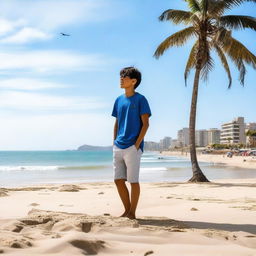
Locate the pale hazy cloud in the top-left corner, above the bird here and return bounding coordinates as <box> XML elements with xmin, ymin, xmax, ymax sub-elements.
<box><xmin>0</xmin><ymin>0</ymin><xmax>113</xmax><ymax>29</ymax></box>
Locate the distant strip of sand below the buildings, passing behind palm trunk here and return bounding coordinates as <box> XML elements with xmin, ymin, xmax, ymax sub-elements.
<box><xmin>161</xmin><ymin>151</ymin><xmax>256</xmax><ymax>170</ymax></box>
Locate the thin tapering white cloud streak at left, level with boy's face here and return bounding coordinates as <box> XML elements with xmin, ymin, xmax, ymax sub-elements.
<box><xmin>0</xmin><ymin>78</ymin><xmax>68</xmax><ymax>90</ymax></box>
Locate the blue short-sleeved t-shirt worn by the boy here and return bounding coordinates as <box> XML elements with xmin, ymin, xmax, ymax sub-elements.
<box><xmin>112</xmin><ymin>92</ymin><xmax>151</xmax><ymax>151</ymax></box>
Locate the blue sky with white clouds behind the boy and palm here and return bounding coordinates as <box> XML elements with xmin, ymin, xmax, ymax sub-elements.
<box><xmin>0</xmin><ymin>0</ymin><xmax>256</xmax><ymax>150</ymax></box>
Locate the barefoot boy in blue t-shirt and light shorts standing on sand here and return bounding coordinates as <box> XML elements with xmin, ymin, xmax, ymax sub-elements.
<box><xmin>112</xmin><ymin>67</ymin><xmax>151</xmax><ymax>219</ymax></box>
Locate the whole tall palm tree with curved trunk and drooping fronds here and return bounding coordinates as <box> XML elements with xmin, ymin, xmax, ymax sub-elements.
<box><xmin>154</xmin><ymin>0</ymin><xmax>256</xmax><ymax>182</ymax></box>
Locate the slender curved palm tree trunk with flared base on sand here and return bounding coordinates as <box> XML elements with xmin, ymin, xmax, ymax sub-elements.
<box><xmin>189</xmin><ymin>68</ymin><xmax>209</xmax><ymax>182</ymax></box>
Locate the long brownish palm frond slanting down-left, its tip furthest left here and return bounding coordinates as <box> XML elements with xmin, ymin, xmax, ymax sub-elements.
<box><xmin>154</xmin><ymin>27</ymin><xmax>196</xmax><ymax>58</ymax></box>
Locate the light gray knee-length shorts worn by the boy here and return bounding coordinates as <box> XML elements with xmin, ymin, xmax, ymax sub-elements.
<box><xmin>113</xmin><ymin>145</ymin><xmax>142</xmax><ymax>183</ymax></box>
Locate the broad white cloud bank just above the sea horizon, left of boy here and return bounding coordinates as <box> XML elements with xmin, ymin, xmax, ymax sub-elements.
<box><xmin>0</xmin><ymin>113</ymin><xmax>113</xmax><ymax>150</ymax></box>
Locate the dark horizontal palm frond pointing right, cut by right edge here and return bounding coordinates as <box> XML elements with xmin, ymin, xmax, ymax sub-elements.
<box><xmin>219</xmin><ymin>15</ymin><xmax>256</xmax><ymax>30</ymax></box>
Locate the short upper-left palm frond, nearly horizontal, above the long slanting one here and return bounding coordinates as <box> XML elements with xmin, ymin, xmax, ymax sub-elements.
<box><xmin>159</xmin><ymin>9</ymin><xmax>197</xmax><ymax>24</ymax></box>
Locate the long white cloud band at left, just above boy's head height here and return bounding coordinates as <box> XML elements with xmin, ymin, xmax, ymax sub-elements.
<box><xmin>0</xmin><ymin>50</ymin><xmax>106</xmax><ymax>74</ymax></box>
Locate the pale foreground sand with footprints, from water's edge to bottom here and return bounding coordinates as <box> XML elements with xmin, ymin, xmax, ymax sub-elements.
<box><xmin>0</xmin><ymin>179</ymin><xmax>256</xmax><ymax>256</ymax></box>
